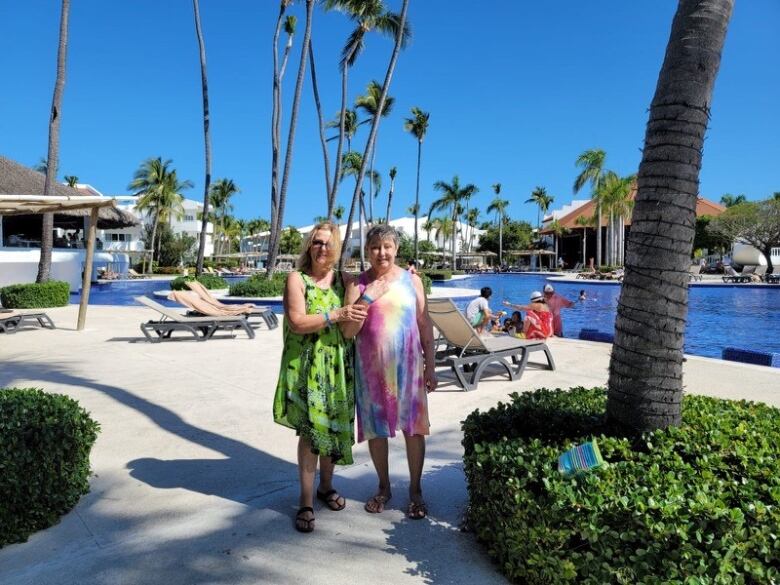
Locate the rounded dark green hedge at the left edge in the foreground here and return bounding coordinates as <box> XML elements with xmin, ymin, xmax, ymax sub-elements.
<box><xmin>0</xmin><ymin>388</ymin><xmax>100</xmax><ymax>547</ymax></box>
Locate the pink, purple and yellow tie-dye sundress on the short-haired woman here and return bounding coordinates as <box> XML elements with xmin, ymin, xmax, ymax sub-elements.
<box><xmin>355</xmin><ymin>270</ymin><xmax>430</xmax><ymax>441</ymax></box>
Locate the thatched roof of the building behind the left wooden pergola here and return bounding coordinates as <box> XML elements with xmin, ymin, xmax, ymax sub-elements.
<box><xmin>0</xmin><ymin>155</ymin><xmax>140</xmax><ymax>230</ymax></box>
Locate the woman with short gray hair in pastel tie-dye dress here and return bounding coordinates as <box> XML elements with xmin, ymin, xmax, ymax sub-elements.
<box><xmin>343</xmin><ymin>224</ymin><xmax>437</xmax><ymax>519</ymax></box>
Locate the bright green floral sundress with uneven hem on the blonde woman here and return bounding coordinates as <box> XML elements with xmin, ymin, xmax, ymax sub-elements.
<box><xmin>274</xmin><ymin>272</ymin><xmax>355</xmax><ymax>465</ymax></box>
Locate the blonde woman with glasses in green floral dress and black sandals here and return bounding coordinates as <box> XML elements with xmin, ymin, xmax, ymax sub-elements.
<box><xmin>274</xmin><ymin>222</ymin><xmax>367</xmax><ymax>532</ymax></box>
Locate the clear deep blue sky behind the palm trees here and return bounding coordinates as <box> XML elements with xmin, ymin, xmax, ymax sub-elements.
<box><xmin>0</xmin><ymin>0</ymin><xmax>780</xmax><ymax>225</ymax></box>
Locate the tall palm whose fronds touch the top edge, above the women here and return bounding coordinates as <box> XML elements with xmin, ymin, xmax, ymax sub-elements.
<box><xmin>323</xmin><ymin>0</ymin><xmax>411</xmax><ymax>210</ymax></box>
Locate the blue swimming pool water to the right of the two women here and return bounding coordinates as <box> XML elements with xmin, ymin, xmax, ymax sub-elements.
<box><xmin>436</xmin><ymin>274</ymin><xmax>780</xmax><ymax>358</ymax></box>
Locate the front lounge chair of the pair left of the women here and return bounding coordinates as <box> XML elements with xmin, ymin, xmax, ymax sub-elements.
<box><xmin>134</xmin><ymin>297</ymin><xmax>255</xmax><ymax>343</ymax></box>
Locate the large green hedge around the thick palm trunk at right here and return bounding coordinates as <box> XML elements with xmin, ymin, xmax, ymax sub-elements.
<box><xmin>463</xmin><ymin>388</ymin><xmax>780</xmax><ymax>585</ymax></box>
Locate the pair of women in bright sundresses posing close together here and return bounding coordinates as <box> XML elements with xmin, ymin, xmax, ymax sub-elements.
<box><xmin>274</xmin><ymin>222</ymin><xmax>436</xmax><ymax>532</ymax></box>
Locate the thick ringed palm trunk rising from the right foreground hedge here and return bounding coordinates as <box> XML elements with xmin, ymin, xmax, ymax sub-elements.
<box><xmin>607</xmin><ymin>0</ymin><xmax>734</xmax><ymax>431</ymax></box>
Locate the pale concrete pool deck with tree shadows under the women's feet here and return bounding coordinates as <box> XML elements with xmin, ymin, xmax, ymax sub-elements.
<box><xmin>0</xmin><ymin>305</ymin><xmax>780</xmax><ymax>585</ymax></box>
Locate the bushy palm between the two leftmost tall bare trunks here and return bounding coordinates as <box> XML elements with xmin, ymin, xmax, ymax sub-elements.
<box><xmin>128</xmin><ymin>157</ymin><xmax>192</xmax><ymax>271</ymax></box>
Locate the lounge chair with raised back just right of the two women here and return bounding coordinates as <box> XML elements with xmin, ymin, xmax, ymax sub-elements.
<box><xmin>428</xmin><ymin>299</ymin><xmax>555</xmax><ymax>390</ymax></box>
